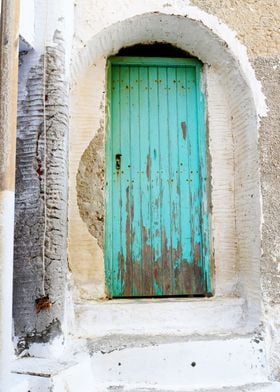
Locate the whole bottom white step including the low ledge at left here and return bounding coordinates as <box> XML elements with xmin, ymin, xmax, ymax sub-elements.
<box><xmin>8</xmin><ymin>335</ymin><xmax>274</xmax><ymax>392</ymax></box>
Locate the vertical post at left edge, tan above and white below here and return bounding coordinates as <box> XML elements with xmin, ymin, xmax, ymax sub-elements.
<box><xmin>0</xmin><ymin>0</ymin><xmax>19</xmax><ymax>391</ymax></box>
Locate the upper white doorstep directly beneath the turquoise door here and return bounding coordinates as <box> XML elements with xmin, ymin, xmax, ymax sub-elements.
<box><xmin>73</xmin><ymin>298</ymin><xmax>247</xmax><ymax>338</ymax></box>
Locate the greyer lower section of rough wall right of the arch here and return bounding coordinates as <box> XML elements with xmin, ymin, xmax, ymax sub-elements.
<box><xmin>253</xmin><ymin>56</ymin><xmax>280</xmax><ymax>380</ymax></box>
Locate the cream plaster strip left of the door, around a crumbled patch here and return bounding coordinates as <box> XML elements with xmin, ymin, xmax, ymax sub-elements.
<box><xmin>68</xmin><ymin>58</ymin><xmax>106</xmax><ymax>299</ymax></box>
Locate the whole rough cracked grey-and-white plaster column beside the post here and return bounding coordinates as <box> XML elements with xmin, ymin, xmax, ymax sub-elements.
<box><xmin>14</xmin><ymin>31</ymin><xmax>68</xmax><ymax>350</ymax></box>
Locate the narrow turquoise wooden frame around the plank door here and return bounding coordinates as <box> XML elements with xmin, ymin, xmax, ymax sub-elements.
<box><xmin>104</xmin><ymin>56</ymin><xmax>214</xmax><ymax>298</ymax></box>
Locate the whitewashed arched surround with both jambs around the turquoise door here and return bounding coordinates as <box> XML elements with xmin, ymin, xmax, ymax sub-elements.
<box><xmin>69</xmin><ymin>11</ymin><xmax>263</xmax><ymax>328</ymax></box>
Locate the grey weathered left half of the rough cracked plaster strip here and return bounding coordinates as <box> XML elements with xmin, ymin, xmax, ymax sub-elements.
<box><xmin>13</xmin><ymin>52</ymin><xmax>44</xmax><ymax>334</ymax></box>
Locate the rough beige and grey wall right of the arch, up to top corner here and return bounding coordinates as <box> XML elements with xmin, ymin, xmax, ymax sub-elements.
<box><xmin>192</xmin><ymin>0</ymin><xmax>280</xmax><ymax>379</ymax></box>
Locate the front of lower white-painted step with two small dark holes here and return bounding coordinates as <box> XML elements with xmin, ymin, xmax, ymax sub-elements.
<box><xmin>88</xmin><ymin>336</ymin><xmax>270</xmax><ymax>392</ymax></box>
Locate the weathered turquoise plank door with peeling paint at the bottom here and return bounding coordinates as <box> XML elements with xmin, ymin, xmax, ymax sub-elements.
<box><xmin>105</xmin><ymin>57</ymin><xmax>211</xmax><ymax>297</ymax></box>
